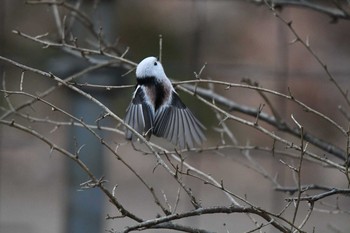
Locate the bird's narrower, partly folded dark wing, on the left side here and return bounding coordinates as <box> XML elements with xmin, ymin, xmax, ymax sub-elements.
<box><xmin>124</xmin><ymin>86</ymin><xmax>154</xmax><ymax>140</ymax></box>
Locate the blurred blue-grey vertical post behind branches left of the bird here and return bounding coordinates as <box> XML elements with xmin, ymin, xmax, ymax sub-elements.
<box><xmin>65</xmin><ymin>0</ymin><xmax>118</xmax><ymax>233</ymax></box>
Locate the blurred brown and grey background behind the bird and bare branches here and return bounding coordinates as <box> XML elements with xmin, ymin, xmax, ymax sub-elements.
<box><xmin>0</xmin><ymin>0</ymin><xmax>350</xmax><ymax>233</ymax></box>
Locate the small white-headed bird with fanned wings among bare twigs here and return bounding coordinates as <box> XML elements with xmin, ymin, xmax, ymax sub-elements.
<box><xmin>124</xmin><ymin>56</ymin><xmax>206</xmax><ymax>149</ymax></box>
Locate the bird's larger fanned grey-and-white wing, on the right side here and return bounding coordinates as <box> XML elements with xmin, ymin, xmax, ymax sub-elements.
<box><xmin>153</xmin><ymin>92</ymin><xmax>205</xmax><ymax>148</ymax></box>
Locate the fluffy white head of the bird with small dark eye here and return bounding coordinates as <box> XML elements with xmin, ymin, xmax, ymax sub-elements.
<box><xmin>136</xmin><ymin>57</ymin><xmax>166</xmax><ymax>80</ymax></box>
